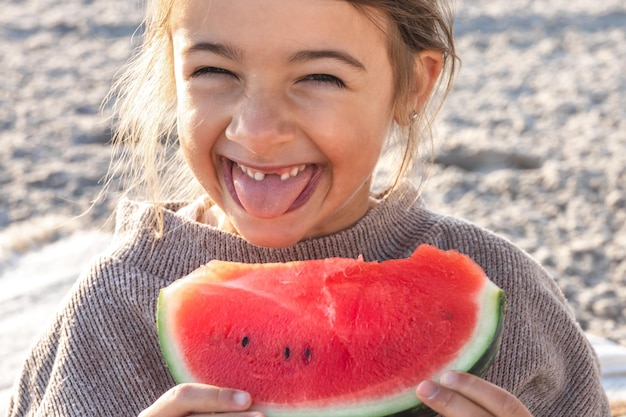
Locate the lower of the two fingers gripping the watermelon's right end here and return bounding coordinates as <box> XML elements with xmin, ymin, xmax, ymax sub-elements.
<box><xmin>417</xmin><ymin>381</ymin><xmax>495</xmax><ymax>417</ymax></box>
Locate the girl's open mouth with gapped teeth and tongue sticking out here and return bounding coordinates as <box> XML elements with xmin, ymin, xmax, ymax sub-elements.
<box><xmin>221</xmin><ymin>157</ymin><xmax>322</xmax><ymax>219</ymax></box>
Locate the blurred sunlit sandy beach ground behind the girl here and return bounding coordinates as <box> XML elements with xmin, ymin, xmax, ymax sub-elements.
<box><xmin>0</xmin><ymin>0</ymin><xmax>626</xmax><ymax>415</ymax></box>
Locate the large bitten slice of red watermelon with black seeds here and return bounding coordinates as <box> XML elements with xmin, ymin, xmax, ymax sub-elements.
<box><xmin>157</xmin><ymin>245</ymin><xmax>505</xmax><ymax>417</ymax></box>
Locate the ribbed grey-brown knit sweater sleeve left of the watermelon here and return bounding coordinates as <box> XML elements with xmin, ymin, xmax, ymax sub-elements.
<box><xmin>8</xmin><ymin>256</ymin><xmax>174</xmax><ymax>417</ymax></box>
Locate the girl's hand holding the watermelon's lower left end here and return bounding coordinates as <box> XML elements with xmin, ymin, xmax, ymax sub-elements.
<box><xmin>139</xmin><ymin>384</ymin><xmax>263</xmax><ymax>417</ymax></box>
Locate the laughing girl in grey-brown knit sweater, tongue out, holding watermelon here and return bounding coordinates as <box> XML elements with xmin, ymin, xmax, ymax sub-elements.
<box><xmin>10</xmin><ymin>0</ymin><xmax>609</xmax><ymax>417</ymax></box>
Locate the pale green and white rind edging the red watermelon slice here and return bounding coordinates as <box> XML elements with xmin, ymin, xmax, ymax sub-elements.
<box><xmin>157</xmin><ymin>281</ymin><xmax>506</xmax><ymax>417</ymax></box>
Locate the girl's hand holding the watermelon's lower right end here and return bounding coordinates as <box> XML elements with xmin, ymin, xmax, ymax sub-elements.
<box><xmin>417</xmin><ymin>372</ymin><xmax>532</xmax><ymax>417</ymax></box>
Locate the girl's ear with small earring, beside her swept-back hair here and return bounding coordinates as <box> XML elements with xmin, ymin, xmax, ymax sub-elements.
<box><xmin>396</xmin><ymin>50</ymin><xmax>443</xmax><ymax>125</ymax></box>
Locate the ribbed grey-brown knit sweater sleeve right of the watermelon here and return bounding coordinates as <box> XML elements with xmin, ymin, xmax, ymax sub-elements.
<box><xmin>424</xmin><ymin>218</ymin><xmax>610</xmax><ymax>417</ymax></box>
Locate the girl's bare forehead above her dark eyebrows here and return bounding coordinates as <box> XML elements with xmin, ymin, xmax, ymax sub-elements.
<box><xmin>170</xmin><ymin>0</ymin><xmax>387</xmax><ymax>57</ymax></box>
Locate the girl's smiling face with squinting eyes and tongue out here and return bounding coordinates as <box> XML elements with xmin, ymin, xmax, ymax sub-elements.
<box><xmin>172</xmin><ymin>0</ymin><xmax>394</xmax><ymax>247</ymax></box>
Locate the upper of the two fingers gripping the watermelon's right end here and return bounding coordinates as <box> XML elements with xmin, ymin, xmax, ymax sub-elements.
<box><xmin>440</xmin><ymin>372</ymin><xmax>532</xmax><ymax>417</ymax></box>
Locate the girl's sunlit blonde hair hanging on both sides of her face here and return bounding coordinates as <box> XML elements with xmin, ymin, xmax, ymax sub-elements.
<box><xmin>108</xmin><ymin>0</ymin><xmax>458</xmax><ymax>231</ymax></box>
